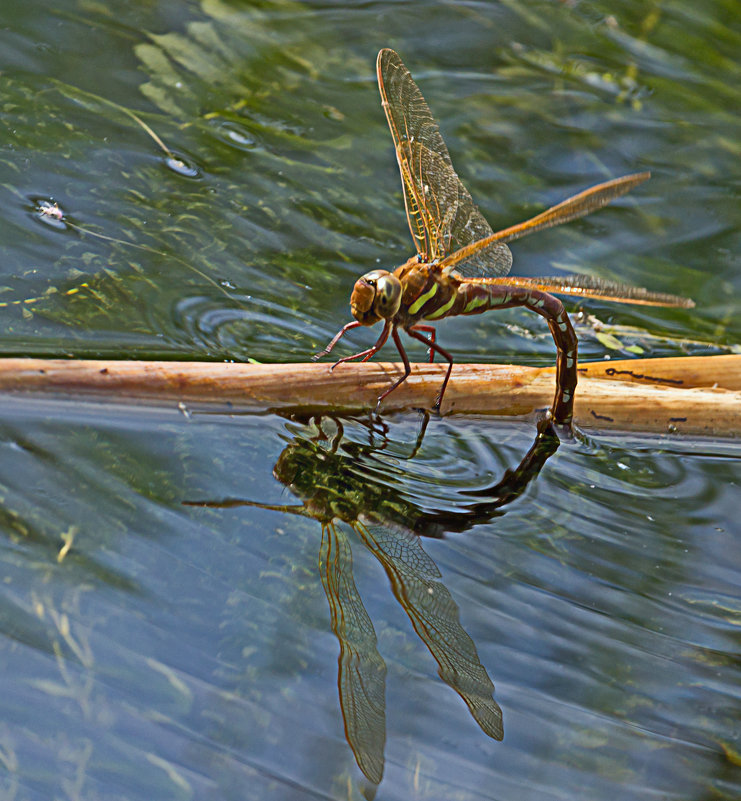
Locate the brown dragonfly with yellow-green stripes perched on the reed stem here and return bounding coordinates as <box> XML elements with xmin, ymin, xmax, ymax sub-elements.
<box><xmin>314</xmin><ymin>48</ymin><xmax>695</xmax><ymax>430</ymax></box>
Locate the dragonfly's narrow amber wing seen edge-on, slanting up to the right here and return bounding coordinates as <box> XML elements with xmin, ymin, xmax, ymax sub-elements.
<box><xmin>440</xmin><ymin>172</ymin><xmax>651</xmax><ymax>275</ymax></box>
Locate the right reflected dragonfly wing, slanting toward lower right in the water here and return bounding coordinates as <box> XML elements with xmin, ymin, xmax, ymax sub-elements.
<box><xmin>356</xmin><ymin>517</ymin><xmax>504</xmax><ymax>740</ymax></box>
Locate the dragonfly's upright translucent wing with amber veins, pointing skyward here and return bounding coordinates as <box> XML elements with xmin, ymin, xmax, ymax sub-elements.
<box><xmin>376</xmin><ymin>49</ymin><xmax>512</xmax><ymax>276</ymax></box>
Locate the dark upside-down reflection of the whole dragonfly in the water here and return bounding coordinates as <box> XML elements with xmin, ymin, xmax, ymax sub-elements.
<box><xmin>188</xmin><ymin>418</ymin><xmax>558</xmax><ymax>784</ymax></box>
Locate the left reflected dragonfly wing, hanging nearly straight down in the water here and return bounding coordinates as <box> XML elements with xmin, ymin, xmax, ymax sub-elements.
<box><xmin>321</xmin><ymin>523</ymin><xmax>386</xmax><ymax>784</ymax></box>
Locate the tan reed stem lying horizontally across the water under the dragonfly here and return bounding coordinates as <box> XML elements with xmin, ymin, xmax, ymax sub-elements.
<box><xmin>0</xmin><ymin>355</ymin><xmax>741</xmax><ymax>436</ymax></box>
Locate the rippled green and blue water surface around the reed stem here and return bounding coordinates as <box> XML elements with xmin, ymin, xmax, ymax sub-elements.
<box><xmin>0</xmin><ymin>0</ymin><xmax>741</xmax><ymax>801</ymax></box>
